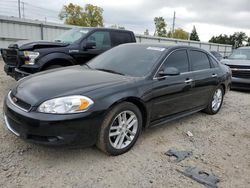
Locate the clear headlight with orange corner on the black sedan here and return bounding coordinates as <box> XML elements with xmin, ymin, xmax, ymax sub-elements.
<box><xmin>38</xmin><ymin>95</ymin><xmax>94</xmax><ymax>114</ymax></box>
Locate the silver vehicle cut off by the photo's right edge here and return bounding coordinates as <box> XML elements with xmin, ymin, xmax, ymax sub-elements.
<box><xmin>221</xmin><ymin>47</ymin><xmax>250</xmax><ymax>90</ymax></box>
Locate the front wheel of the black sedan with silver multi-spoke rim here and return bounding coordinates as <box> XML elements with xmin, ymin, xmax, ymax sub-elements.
<box><xmin>96</xmin><ymin>102</ymin><xmax>142</xmax><ymax>156</ymax></box>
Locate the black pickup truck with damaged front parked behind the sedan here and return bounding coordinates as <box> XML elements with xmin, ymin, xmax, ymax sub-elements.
<box><xmin>1</xmin><ymin>28</ymin><xmax>136</xmax><ymax>80</ymax></box>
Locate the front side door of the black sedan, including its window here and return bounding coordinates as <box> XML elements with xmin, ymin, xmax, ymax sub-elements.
<box><xmin>151</xmin><ymin>49</ymin><xmax>194</xmax><ymax>121</ymax></box>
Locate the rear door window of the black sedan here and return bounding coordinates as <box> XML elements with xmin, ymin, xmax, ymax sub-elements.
<box><xmin>190</xmin><ymin>50</ymin><xmax>210</xmax><ymax>71</ymax></box>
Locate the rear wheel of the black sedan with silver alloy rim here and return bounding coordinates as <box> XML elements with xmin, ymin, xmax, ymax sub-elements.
<box><xmin>204</xmin><ymin>86</ymin><xmax>225</xmax><ymax>115</ymax></box>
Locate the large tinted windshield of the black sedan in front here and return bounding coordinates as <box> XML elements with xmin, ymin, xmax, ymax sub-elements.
<box><xmin>87</xmin><ymin>44</ymin><xmax>166</xmax><ymax>77</ymax></box>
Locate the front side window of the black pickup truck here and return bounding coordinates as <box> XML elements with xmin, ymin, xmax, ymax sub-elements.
<box><xmin>87</xmin><ymin>31</ymin><xmax>111</xmax><ymax>49</ymax></box>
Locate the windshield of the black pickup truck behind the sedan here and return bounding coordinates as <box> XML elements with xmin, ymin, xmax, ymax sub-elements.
<box><xmin>55</xmin><ymin>28</ymin><xmax>90</xmax><ymax>44</ymax></box>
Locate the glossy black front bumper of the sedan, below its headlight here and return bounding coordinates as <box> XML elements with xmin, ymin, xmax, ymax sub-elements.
<box><xmin>4</xmin><ymin>94</ymin><xmax>104</xmax><ymax>146</ymax></box>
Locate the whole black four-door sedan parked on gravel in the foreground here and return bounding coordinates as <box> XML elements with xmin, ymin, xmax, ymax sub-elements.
<box><xmin>4</xmin><ymin>44</ymin><xmax>231</xmax><ymax>155</ymax></box>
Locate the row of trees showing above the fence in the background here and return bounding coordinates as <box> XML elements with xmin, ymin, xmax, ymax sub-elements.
<box><xmin>59</xmin><ymin>3</ymin><xmax>250</xmax><ymax>48</ymax></box>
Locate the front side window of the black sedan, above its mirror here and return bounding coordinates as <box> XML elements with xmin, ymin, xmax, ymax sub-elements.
<box><xmin>165</xmin><ymin>50</ymin><xmax>188</xmax><ymax>72</ymax></box>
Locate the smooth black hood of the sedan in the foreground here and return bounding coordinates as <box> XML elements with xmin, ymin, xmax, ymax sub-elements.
<box><xmin>12</xmin><ymin>66</ymin><xmax>132</xmax><ymax>106</ymax></box>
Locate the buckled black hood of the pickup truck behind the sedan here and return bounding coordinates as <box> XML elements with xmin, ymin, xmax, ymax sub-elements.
<box><xmin>9</xmin><ymin>41</ymin><xmax>69</xmax><ymax>50</ymax></box>
